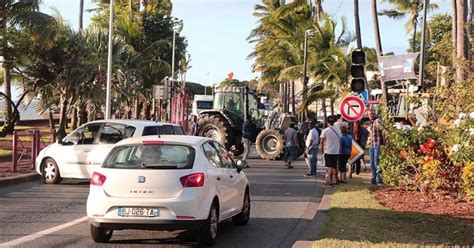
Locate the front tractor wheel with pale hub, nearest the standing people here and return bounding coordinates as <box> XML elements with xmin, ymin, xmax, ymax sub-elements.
<box><xmin>255</xmin><ymin>129</ymin><xmax>285</xmax><ymax>160</ymax></box>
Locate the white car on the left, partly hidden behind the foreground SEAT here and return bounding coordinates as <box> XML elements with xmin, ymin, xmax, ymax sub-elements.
<box><xmin>35</xmin><ymin>120</ymin><xmax>183</xmax><ymax>183</ymax></box>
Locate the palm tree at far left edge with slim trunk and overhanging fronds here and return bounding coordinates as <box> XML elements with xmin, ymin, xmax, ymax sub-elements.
<box><xmin>0</xmin><ymin>0</ymin><xmax>55</xmax><ymax>132</ymax></box>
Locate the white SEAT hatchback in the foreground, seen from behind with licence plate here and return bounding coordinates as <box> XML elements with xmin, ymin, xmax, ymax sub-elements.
<box><xmin>87</xmin><ymin>135</ymin><xmax>250</xmax><ymax>245</ymax></box>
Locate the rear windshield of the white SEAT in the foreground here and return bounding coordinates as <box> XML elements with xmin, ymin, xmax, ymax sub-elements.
<box><xmin>103</xmin><ymin>144</ymin><xmax>195</xmax><ymax>169</ymax></box>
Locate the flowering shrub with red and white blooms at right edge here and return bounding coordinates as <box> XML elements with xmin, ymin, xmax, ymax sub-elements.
<box><xmin>380</xmin><ymin>75</ymin><xmax>474</xmax><ymax>200</ymax></box>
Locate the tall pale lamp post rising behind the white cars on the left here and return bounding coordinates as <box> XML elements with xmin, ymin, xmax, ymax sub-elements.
<box><xmin>104</xmin><ymin>0</ymin><xmax>114</xmax><ymax>120</ymax></box>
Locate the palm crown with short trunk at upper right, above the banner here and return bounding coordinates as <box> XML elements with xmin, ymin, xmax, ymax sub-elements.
<box><xmin>379</xmin><ymin>0</ymin><xmax>438</xmax><ymax>52</ymax></box>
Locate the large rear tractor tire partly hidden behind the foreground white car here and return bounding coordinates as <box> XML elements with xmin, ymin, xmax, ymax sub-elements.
<box><xmin>198</xmin><ymin>115</ymin><xmax>234</xmax><ymax>150</ymax></box>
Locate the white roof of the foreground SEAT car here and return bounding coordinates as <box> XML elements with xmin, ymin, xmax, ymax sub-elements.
<box><xmin>117</xmin><ymin>135</ymin><xmax>212</xmax><ymax>146</ymax></box>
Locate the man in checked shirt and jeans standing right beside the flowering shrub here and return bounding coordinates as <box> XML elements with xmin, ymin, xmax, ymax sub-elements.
<box><xmin>369</xmin><ymin>110</ymin><xmax>384</xmax><ymax>185</ymax></box>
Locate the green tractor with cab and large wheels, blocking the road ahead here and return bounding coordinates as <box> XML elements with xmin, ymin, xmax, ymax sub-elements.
<box><xmin>198</xmin><ymin>87</ymin><xmax>297</xmax><ymax>160</ymax></box>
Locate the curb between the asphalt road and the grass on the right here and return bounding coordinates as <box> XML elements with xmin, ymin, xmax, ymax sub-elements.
<box><xmin>292</xmin><ymin>184</ymin><xmax>334</xmax><ymax>248</ymax></box>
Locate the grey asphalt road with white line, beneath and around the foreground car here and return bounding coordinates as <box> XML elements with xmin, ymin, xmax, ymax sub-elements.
<box><xmin>0</xmin><ymin>155</ymin><xmax>323</xmax><ymax>247</ymax></box>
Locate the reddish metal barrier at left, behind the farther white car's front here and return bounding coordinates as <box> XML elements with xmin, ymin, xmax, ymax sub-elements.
<box><xmin>11</xmin><ymin>129</ymin><xmax>56</xmax><ymax>172</ymax></box>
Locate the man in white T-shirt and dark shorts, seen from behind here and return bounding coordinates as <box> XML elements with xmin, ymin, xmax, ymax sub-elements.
<box><xmin>319</xmin><ymin>115</ymin><xmax>341</xmax><ymax>186</ymax></box>
